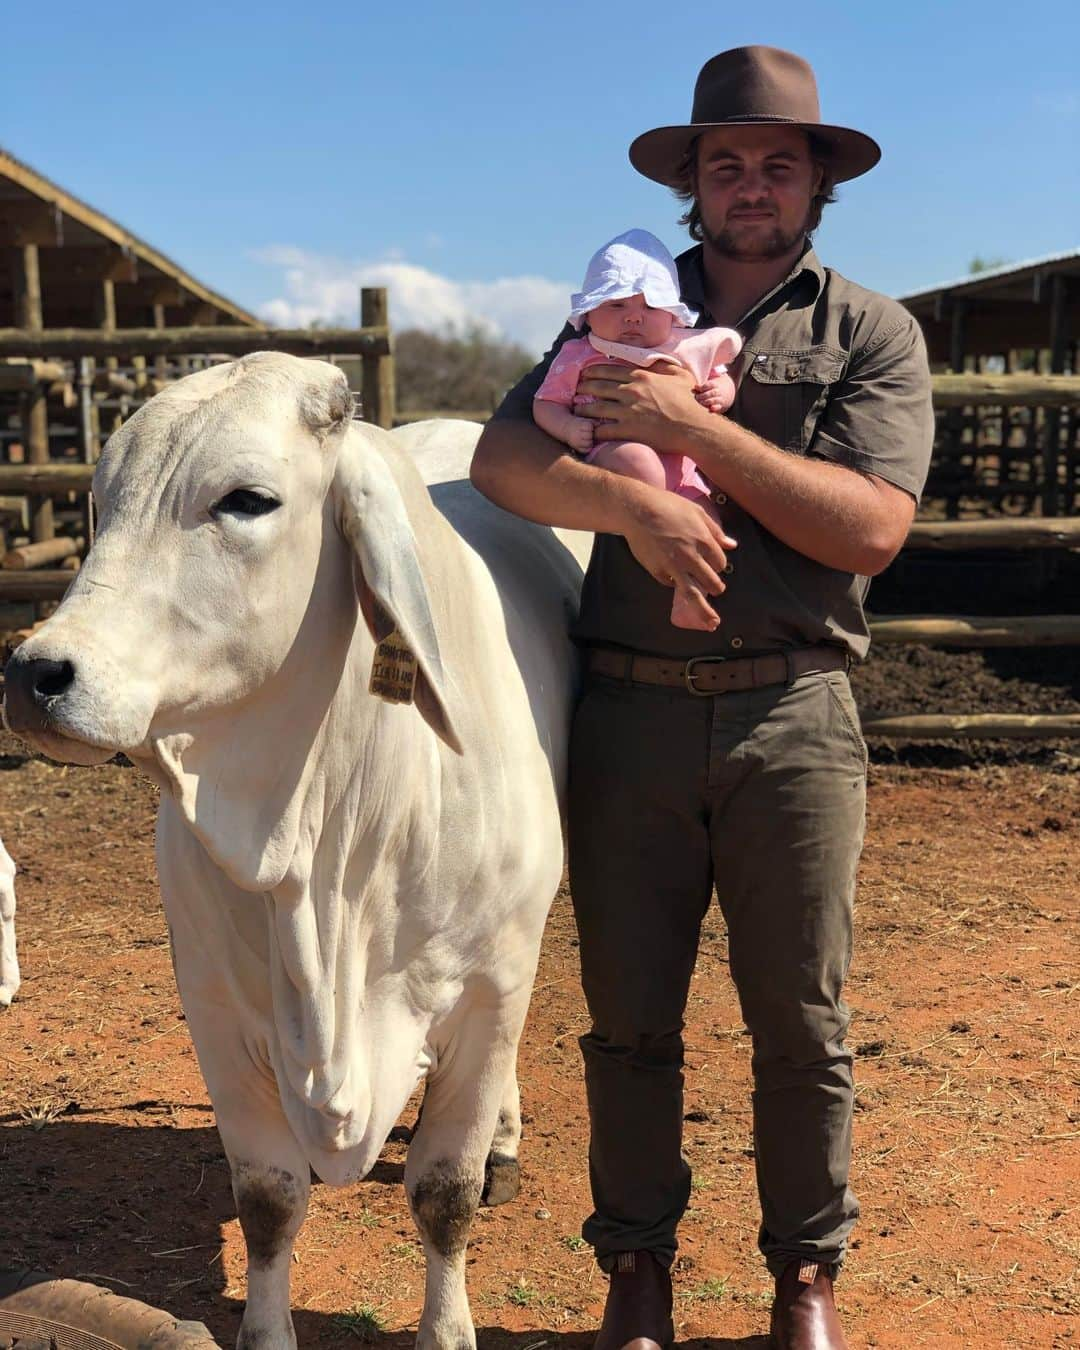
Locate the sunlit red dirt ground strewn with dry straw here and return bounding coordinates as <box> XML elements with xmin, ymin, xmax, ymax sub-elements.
<box><xmin>0</xmin><ymin>738</ymin><xmax>1080</xmax><ymax>1350</ymax></box>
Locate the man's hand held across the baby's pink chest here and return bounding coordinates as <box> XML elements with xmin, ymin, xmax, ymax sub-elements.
<box><xmin>578</xmin><ymin>362</ymin><xmax>710</xmax><ymax>454</ymax></box>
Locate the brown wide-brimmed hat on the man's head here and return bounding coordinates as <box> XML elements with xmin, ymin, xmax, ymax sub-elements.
<box><xmin>630</xmin><ymin>47</ymin><xmax>882</xmax><ymax>188</ymax></box>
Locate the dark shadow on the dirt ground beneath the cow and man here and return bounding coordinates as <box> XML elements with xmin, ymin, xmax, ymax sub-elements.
<box><xmin>0</xmin><ymin>1117</ymin><xmax>767</xmax><ymax>1350</ymax></box>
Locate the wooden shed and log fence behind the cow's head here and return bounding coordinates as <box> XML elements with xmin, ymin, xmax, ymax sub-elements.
<box><xmin>0</xmin><ymin>150</ymin><xmax>394</xmax><ymax>603</ymax></box>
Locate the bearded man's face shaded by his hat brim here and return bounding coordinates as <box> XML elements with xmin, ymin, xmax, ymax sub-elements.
<box><xmin>695</xmin><ymin>126</ymin><xmax>821</xmax><ymax>262</ymax></box>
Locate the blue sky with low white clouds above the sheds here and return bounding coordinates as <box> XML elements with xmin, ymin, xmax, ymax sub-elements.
<box><xmin>0</xmin><ymin>0</ymin><xmax>1080</xmax><ymax>348</ymax></box>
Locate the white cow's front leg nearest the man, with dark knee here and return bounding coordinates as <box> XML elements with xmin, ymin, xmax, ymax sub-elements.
<box><xmin>405</xmin><ymin>1007</ymin><xmax>524</xmax><ymax>1350</ymax></box>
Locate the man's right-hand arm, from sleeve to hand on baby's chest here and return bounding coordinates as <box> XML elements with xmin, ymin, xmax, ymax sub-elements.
<box><xmin>582</xmin><ymin>319</ymin><xmax>933</xmax><ymax>576</ymax></box>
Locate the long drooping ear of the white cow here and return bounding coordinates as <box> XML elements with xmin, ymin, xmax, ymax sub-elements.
<box><xmin>333</xmin><ymin>435</ymin><xmax>462</xmax><ymax>755</ymax></box>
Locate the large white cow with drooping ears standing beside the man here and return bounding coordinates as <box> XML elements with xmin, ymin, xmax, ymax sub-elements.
<box><xmin>7</xmin><ymin>352</ymin><xmax>585</xmax><ymax>1350</ymax></box>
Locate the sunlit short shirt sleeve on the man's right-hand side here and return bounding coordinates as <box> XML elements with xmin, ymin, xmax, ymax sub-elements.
<box><xmin>809</xmin><ymin>315</ymin><xmax>934</xmax><ymax>501</ymax></box>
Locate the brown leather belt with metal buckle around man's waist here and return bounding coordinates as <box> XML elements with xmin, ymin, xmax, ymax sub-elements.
<box><xmin>586</xmin><ymin>647</ymin><xmax>851</xmax><ymax>698</ymax></box>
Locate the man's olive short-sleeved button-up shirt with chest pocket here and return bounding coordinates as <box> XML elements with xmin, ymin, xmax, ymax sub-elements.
<box><xmin>494</xmin><ymin>246</ymin><xmax>934</xmax><ymax>660</ymax></box>
